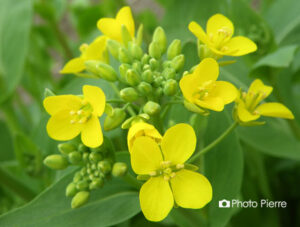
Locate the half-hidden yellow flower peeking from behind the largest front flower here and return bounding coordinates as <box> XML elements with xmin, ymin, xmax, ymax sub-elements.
<box><xmin>127</xmin><ymin>122</ymin><xmax>162</xmax><ymax>152</ymax></box>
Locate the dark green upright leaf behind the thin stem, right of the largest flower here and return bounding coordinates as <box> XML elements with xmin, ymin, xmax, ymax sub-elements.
<box><xmin>204</xmin><ymin>112</ymin><xmax>243</xmax><ymax>227</ymax></box>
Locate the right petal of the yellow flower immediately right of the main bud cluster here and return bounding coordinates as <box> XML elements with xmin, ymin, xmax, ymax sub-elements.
<box><xmin>210</xmin><ymin>81</ymin><xmax>238</xmax><ymax>104</ymax></box>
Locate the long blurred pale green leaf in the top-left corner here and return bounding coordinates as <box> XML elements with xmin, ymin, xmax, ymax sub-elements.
<box><xmin>0</xmin><ymin>0</ymin><xmax>32</xmax><ymax>102</ymax></box>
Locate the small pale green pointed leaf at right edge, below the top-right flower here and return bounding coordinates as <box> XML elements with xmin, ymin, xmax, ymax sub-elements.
<box><xmin>253</xmin><ymin>45</ymin><xmax>298</xmax><ymax>69</ymax></box>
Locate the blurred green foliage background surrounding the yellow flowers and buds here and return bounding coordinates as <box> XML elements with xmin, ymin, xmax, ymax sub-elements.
<box><xmin>0</xmin><ymin>0</ymin><xmax>300</xmax><ymax>227</ymax></box>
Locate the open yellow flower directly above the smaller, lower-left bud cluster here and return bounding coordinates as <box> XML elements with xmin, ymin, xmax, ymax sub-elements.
<box><xmin>44</xmin><ymin>85</ymin><xmax>105</xmax><ymax>147</ymax></box>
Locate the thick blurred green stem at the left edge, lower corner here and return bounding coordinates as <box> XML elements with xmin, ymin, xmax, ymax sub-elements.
<box><xmin>0</xmin><ymin>168</ymin><xmax>35</xmax><ymax>201</ymax></box>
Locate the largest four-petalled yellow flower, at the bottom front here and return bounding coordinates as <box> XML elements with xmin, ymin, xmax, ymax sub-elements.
<box><xmin>131</xmin><ymin>124</ymin><xmax>212</xmax><ymax>221</ymax></box>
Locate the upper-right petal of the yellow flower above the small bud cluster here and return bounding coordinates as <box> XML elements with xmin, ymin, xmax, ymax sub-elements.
<box><xmin>82</xmin><ymin>85</ymin><xmax>105</xmax><ymax>117</ymax></box>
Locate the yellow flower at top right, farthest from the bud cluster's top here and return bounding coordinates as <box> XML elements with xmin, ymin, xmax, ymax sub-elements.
<box><xmin>189</xmin><ymin>14</ymin><xmax>257</xmax><ymax>56</ymax></box>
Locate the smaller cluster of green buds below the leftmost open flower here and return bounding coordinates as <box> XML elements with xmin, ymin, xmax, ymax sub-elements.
<box><xmin>44</xmin><ymin>142</ymin><xmax>127</xmax><ymax>208</ymax></box>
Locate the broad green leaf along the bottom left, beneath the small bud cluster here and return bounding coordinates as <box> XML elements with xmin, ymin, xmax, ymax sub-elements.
<box><xmin>0</xmin><ymin>171</ymin><xmax>140</xmax><ymax>227</ymax></box>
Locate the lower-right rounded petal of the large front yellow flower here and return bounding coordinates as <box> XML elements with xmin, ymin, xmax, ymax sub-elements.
<box><xmin>171</xmin><ymin>169</ymin><xmax>212</xmax><ymax>209</ymax></box>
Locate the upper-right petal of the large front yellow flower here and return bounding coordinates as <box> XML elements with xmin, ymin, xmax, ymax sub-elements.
<box><xmin>161</xmin><ymin>124</ymin><xmax>197</xmax><ymax>164</ymax></box>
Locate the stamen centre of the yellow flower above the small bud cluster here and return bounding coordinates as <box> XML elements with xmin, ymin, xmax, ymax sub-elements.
<box><xmin>70</xmin><ymin>100</ymin><xmax>93</xmax><ymax>124</ymax></box>
